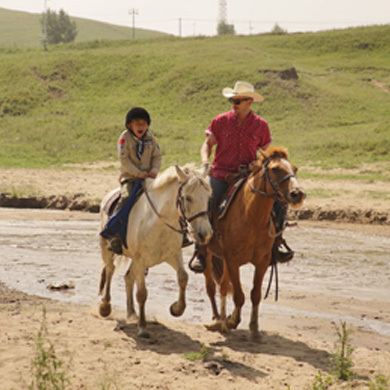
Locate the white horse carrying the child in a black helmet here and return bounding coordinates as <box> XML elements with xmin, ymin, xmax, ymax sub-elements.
<box><xmin>99</xmin><ymin>166</ymin><xmax>213</xmax><ymax>337</ymax></box>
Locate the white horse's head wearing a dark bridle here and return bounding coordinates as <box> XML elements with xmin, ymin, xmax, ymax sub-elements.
<box><xmin>175</xmin><ymin>165</ymin><xmax>213</xmax><ymax>245</ymax></box>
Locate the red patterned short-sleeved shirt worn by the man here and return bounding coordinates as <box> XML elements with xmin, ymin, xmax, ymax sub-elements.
<box><xmin>206</xmin><ymin>111</ymin><xmax>272</xmax><ymax>180</ymax></box>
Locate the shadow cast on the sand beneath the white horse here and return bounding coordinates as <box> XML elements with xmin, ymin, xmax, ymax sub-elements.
<box><xmin>115</xmin><ymin>320</ymin><xmax>268</xmax><ymax>381</ymax></box>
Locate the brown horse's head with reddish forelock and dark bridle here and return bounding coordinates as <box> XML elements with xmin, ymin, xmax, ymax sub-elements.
<box><xmin>252</xmin><ymin>146</ymin><xmax>306</xmax><ymax>208</ymax></box>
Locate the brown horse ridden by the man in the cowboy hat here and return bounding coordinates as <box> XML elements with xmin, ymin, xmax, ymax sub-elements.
<box><xmin>204</xmin><ymin>146</ymin><xmax>306</xmax><ymax>338</ymax></box>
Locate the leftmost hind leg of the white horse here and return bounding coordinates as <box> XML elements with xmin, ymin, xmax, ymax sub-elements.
<box><xmin>99</xmin><ymin>237</ymin><xmax>115</xmax><ymax>317</ymax></box>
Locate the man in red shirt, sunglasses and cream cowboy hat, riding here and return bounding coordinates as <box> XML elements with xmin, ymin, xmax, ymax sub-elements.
<box><xmin>190</xmin><ymin>81</ymin><xmax>293</xmax><ymax>272</ymax></box>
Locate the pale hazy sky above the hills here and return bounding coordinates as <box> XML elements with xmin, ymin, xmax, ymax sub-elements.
<box><xmin>0</xmin><ymin>0</ymin><xmax>390</xmax><ymax>37</ymax></box>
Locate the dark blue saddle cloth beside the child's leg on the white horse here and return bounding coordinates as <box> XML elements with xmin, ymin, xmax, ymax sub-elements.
<box><xmin>100</xmin><ymin>179</ymin><xmax>142</xmax><ymax>248</ymax></box>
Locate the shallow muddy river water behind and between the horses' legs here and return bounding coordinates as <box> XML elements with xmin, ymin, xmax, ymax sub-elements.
<box><xmin>0</xmin><ymin>209</ymin><xmax>390</xmax><ymax>336</ymax></box>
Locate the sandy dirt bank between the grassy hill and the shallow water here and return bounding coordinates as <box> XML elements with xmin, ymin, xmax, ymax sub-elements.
<box><xmin>0</xmin><ymin>164</ymin><xmax>390</xmax><ymax>225</ymax></box>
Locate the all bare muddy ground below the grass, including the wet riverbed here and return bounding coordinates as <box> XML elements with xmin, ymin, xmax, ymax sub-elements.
<box><xmin>0</xmin><ymin>167</ymin><xmax>390</xmax><ymax>390</ymax></box>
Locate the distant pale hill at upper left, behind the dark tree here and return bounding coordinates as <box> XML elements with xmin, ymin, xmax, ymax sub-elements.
<box><xmin>0</xmin><ymin>8</ymin><xmax>167</xmax><ymax>47</ymax></box>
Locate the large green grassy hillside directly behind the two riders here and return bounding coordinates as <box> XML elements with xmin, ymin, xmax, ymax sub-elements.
<box><xmin>0</xmin><ymin>25</ymin><xmax>390</xmax><ymax>181</ymax></box>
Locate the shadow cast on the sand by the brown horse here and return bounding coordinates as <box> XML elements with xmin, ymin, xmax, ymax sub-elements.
<box><xmin>213</xmin><ymin>330</ymin><xmax>332</xmax><ymax>372</ymax></box>
